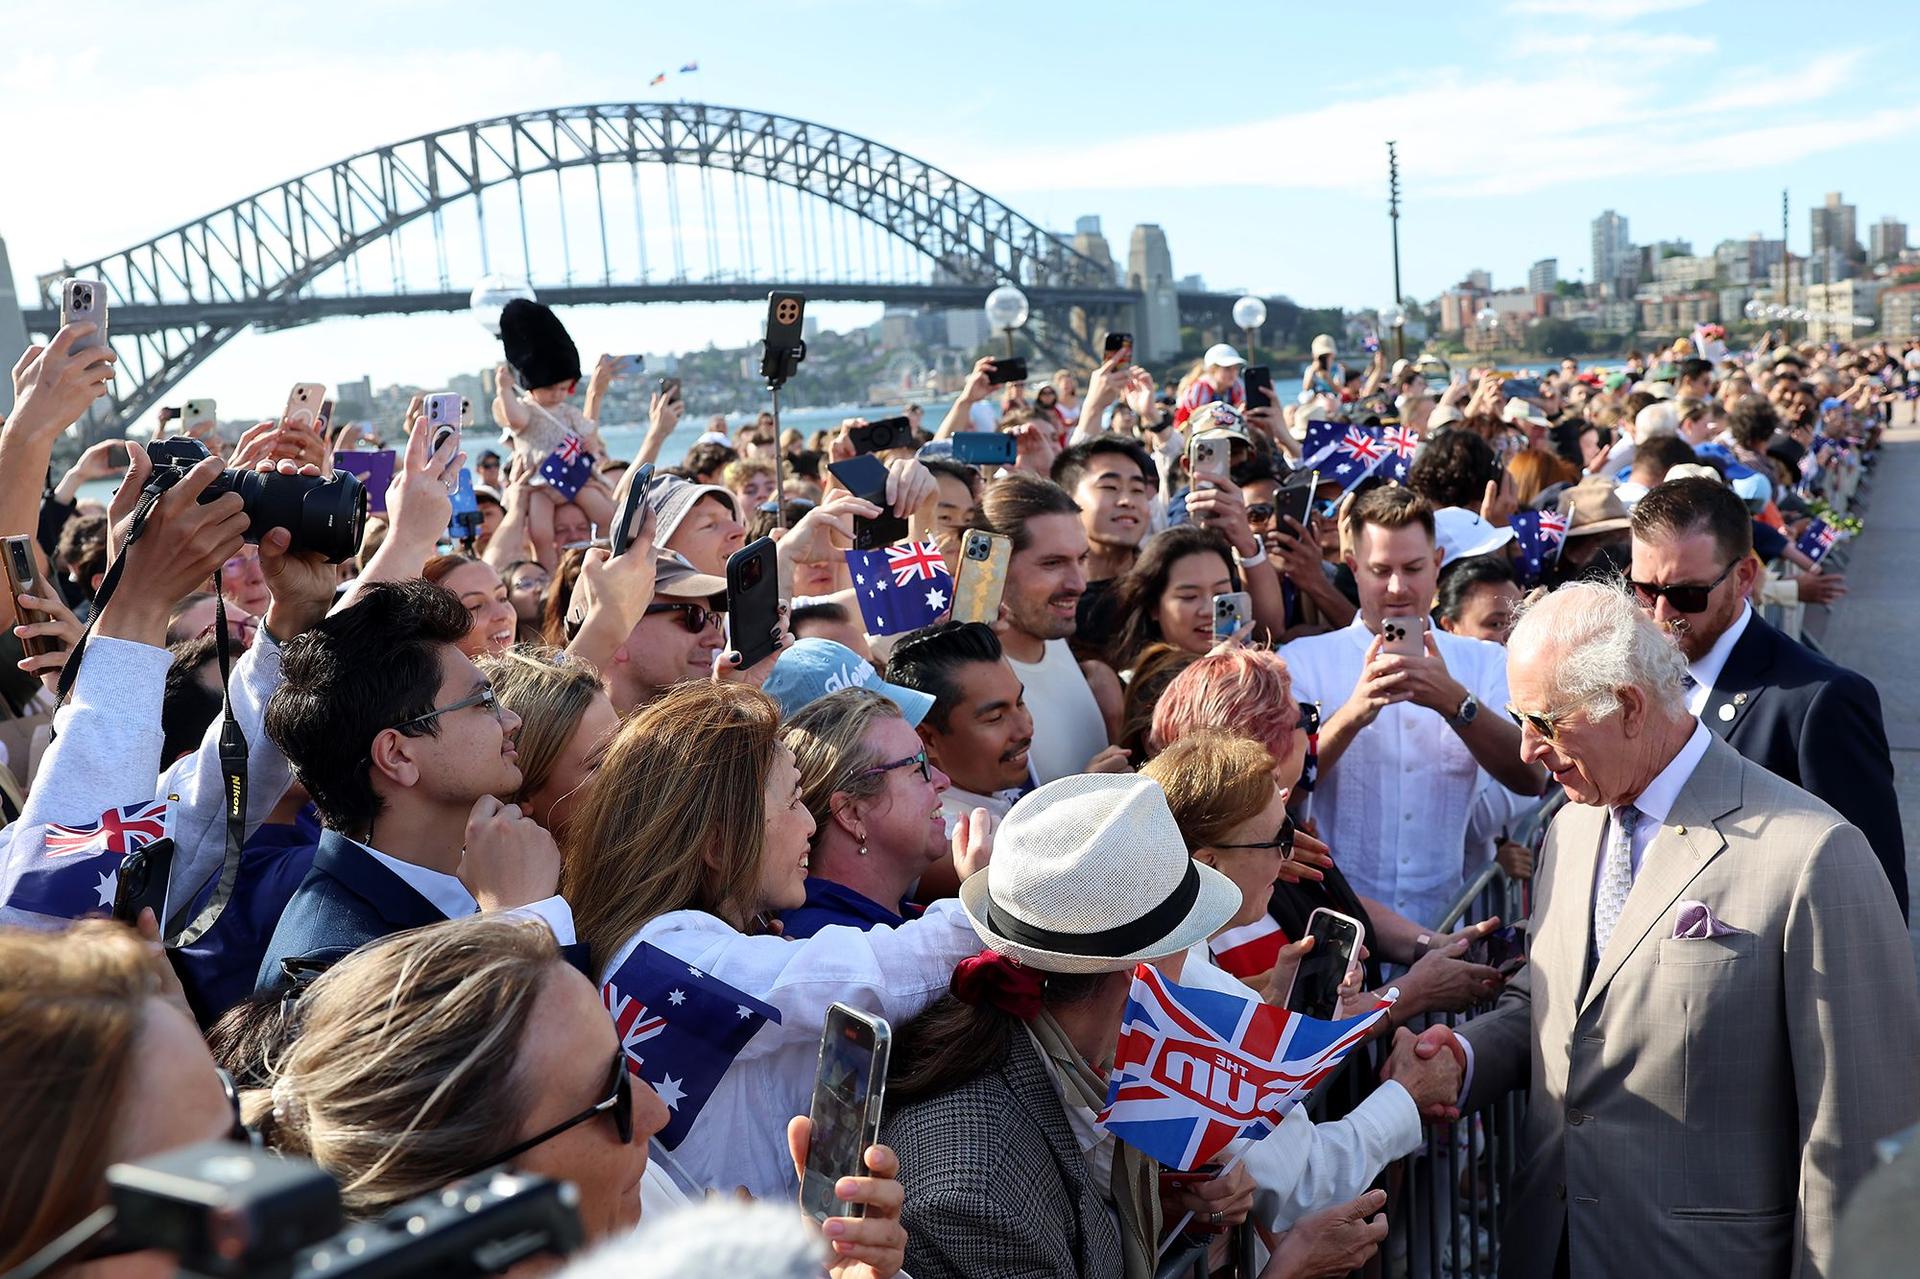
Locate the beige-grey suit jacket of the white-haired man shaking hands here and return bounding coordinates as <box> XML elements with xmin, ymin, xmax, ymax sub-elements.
<box><xmin>1463</xmin><ymin>739</ymin><xmax>1920</xmax><ymax>1279</ymax></box>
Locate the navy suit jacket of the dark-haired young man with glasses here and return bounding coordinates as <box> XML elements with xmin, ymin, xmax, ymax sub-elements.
<box><xmin>253</xmin><ymin>830</ymin><xmax>447</xmax><ymax>991</ymax></box>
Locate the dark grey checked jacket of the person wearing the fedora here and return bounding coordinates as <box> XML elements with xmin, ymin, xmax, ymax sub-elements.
<box><xmin>879</xmin><ymin>1033</ymin><xmax>1125</xmax><ymax>1279</ymax></box>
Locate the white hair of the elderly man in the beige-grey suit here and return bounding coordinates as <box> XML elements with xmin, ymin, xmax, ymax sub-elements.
<box><xmin>1507</xmin><ymin>580</ymin><xmax>1686</xmax><ymax>720</ymax></box>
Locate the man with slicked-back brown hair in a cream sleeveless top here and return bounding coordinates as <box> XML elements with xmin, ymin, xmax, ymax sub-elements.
<box><xmin>981</xmin><ymin>472</ymin><xmax>1127</xmax><ymax>785</ymax></box>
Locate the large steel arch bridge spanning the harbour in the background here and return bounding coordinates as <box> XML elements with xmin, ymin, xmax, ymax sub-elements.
<box><xmin>0</xmin><ymin>102</ymin><xmax>1298</xmax><ymax>434</ymax></box>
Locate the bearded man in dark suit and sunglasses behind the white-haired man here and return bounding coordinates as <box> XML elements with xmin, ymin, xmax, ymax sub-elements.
<box><xmin>1630</xmin><ymin>478</ymin><xmax>1907</xmax><ymax>918</ymax></box>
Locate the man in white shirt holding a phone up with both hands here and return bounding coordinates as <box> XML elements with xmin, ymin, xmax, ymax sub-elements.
<box><xmin>1281</xmin><ymin>486</ymin><xmax>1546</xmax><ymax>933</ymax></box>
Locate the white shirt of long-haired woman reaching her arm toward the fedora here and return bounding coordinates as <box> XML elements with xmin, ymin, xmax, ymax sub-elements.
<box><xmin>595</xmin><ymin>899</ymin><xmax>981</xmax><ymax>1202</ymax></box>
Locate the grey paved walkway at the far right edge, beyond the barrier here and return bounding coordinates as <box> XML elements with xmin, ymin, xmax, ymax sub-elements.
<box><xmin>1807</xmin><ymin>401</ymin><xmax>1920</xmax><ymax>967</ymax></box>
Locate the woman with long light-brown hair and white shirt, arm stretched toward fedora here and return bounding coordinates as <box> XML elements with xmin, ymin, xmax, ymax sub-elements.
<box><xmin>561</xmin><ymin>684</ymin><xmax>989</xmax><ymax>1196</ymax></box>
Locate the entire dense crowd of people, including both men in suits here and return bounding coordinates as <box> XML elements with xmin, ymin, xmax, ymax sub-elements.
<box><xmin>0</xmin><ymin>302</ymin><xmax>1920</xmax><ymax>1279</ymax></box>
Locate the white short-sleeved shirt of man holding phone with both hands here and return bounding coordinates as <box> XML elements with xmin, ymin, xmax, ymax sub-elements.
<box><xmin>1282</xmin><ymin>615</ymin><xmax>1507</xmax><ymax>926</ymax></box>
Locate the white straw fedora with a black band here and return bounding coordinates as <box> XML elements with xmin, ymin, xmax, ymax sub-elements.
<box><xmin>960</xmin><ymin>772</ymin><xmax>1240</xmax><ymax>972</ymax></box>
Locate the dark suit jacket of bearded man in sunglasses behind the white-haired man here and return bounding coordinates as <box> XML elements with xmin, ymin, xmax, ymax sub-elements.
<box><xmin>1699</xmin><ymin>615</ymin><xmax>1907</xmax><ymax>920</ymax></box>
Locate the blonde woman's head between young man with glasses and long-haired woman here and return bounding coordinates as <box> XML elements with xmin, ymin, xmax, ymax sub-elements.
<box><xmin>480</xmin><ymin>647</ymin><xmax>620</xmax><ymax>839</ymax></box>
